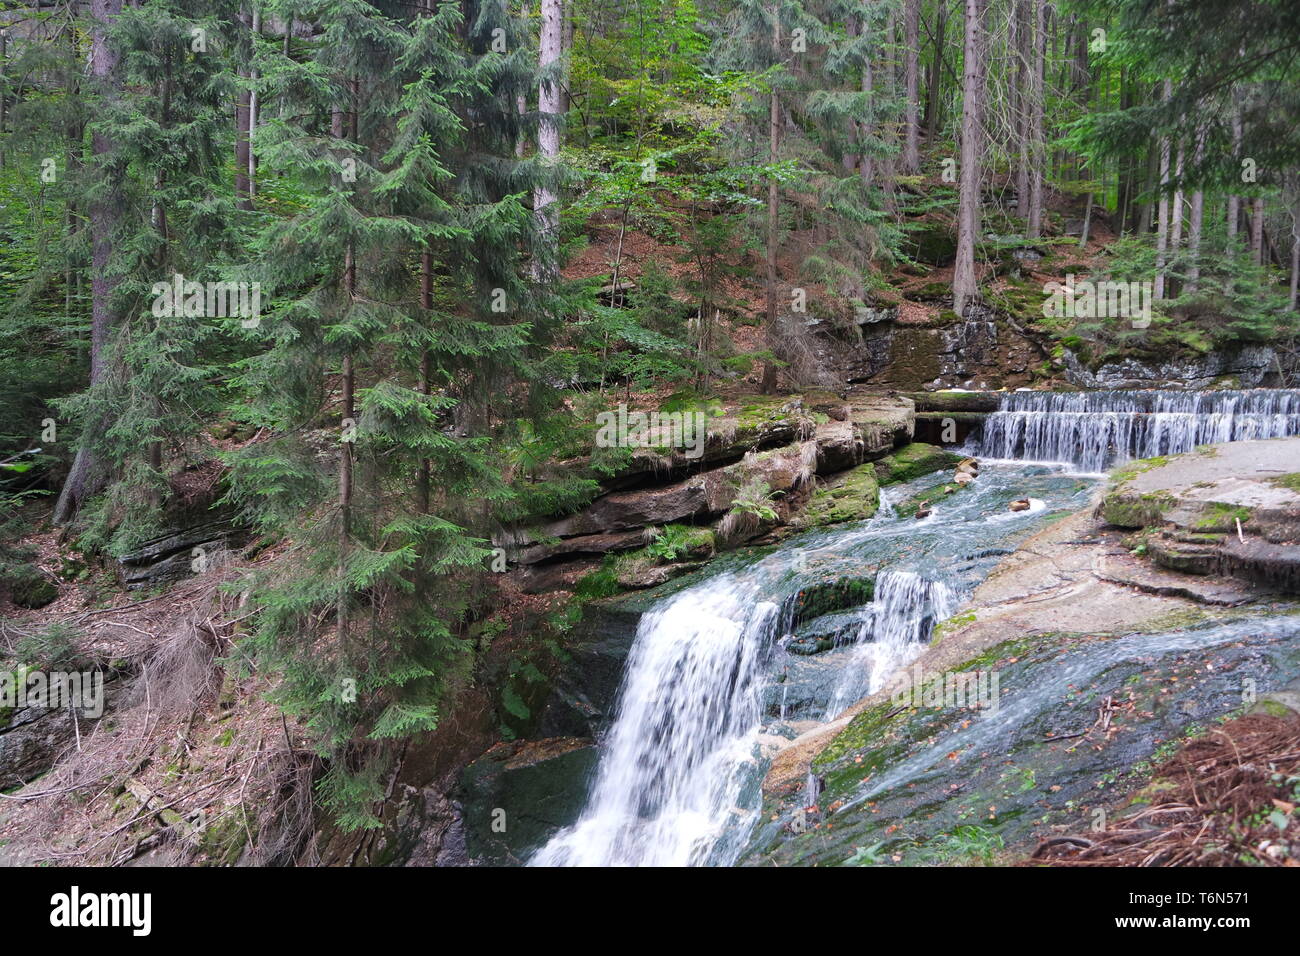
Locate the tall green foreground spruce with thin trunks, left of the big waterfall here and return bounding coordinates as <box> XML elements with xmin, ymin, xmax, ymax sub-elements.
<box><xmin>223</xmin><ymin>0</ymin><xmax>559</xmax><ymax>827</ymax></box>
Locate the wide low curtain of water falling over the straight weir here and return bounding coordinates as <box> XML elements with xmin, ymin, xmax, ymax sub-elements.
<box><xmin>978</xmin><ymin>389</ymin><xmax>1300</xmax><ymax>471</ymax></box>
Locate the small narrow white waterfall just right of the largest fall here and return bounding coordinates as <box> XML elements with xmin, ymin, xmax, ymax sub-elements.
<box><xmin>824</xmin><ymin>571</ymin><xmax>957</xmax><ymax>721</ymax></box>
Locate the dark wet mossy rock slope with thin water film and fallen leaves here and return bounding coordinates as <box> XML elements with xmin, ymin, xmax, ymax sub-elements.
<box><xmin>742</xmin><ymin>618</ymin><xmax>1300</xmax><ymax>865</ymax></box>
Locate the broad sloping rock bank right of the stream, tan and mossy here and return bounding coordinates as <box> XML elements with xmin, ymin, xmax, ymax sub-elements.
<box><xmin>742</xmin><ymin>440</ymin><xmax>1300</xmax><ymax>865</ymax></box>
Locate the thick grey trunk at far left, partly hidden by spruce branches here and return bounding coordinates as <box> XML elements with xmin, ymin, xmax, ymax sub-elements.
<box><xmin>55</xmin><ymin>0</ymin><xmax>122</xmax><ymax>524</ymax></box>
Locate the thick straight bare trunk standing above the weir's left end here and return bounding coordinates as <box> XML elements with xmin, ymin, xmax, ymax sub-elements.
<box><xmin>953</xmin><ymin>0</ymin><xmax>988</xmax><ymax>316</ymax></box>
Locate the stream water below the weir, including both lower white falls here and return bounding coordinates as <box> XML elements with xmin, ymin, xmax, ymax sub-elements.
<box><xmin>529</xmin><ymin>466</ymin><xmax>1088</xmax><ymax>866</ymax></box>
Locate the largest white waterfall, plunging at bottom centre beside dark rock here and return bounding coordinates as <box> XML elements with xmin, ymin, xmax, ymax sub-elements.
<box><xmin>530</xmin><ymin>575</ymin><xmax>781</xmax><ymax>866</ymax></box>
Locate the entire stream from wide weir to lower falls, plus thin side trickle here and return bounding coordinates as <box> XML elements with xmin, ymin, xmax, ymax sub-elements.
<box><xmin>530</xmin><ymin>390</ymin><xmax>1300</xmax><ymax>866</ymax></box>
